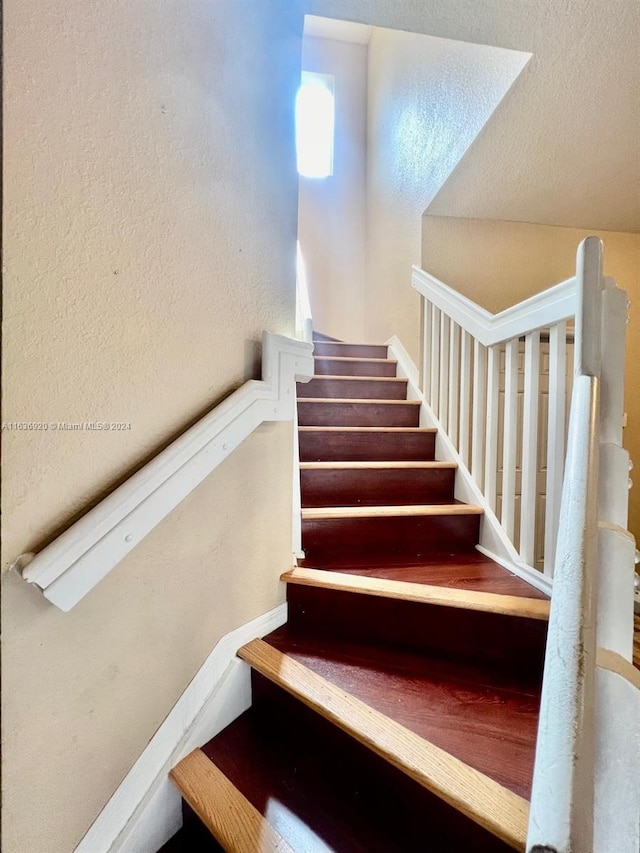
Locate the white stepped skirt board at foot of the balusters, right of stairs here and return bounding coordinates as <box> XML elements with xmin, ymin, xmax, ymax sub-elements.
<box><xmin>386</xmin><ymin>335</ymin><xmax>553</xmax><ymax>595</ymax></box>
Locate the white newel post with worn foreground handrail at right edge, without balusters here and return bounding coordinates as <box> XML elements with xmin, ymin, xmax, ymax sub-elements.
<box><xmin>527</xmin><ymin>237</ymin><xmax>640</xmax><ymax>853</ymax></box>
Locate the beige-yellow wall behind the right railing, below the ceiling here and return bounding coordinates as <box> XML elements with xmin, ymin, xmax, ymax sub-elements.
<box><xmin>422</xmin><ymin>216</ymin><xmax>640</xmax><ymax>540</ymax></box>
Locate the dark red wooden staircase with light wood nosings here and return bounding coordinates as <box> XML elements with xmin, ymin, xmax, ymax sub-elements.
<box><xmin>166</xmin><ymin>340</ymin><xmax>549</xmax><ymax>853</ymax></box>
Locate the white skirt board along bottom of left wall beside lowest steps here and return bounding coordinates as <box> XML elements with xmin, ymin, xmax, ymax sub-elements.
<box><xmin>75</xmin><ymin>604</ymin><xmax>287</xmax><ymax>853</ymax></box>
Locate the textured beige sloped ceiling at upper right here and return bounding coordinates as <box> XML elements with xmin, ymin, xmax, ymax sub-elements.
<box><xmin>307</xmin><ymin>0</ymin><xmax>640</xmax><ymax>231</ymax></box>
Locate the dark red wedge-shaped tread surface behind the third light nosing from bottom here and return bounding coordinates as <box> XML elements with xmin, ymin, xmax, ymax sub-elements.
<box><xmin>298</xmin><ymin>551</ymin><xmax>549</xmax><ymax>601</ymax></box>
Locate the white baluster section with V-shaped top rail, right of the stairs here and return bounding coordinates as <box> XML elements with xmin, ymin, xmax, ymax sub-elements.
<box><xmin>412</xmin><ymin>268</ymin><xmax>576</xmax><ymax>577</ymax></box>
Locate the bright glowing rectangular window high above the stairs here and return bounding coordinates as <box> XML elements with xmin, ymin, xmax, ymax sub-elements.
<box><xmin>296</xmin><ymin>71</ymin><xmax>334</xmax><ymax>178</ymax></box>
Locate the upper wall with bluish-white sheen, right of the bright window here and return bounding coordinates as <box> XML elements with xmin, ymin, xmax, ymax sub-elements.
<box><xmin>365</xmin><ymin>28</ymin><xmax>527</xmax><ymax>354</ymax></box>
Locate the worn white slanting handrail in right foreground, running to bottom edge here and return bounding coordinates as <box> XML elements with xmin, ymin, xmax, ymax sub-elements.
<box><xmin>527</xmin><ymin>376</ymin><xmax>599</xmax><ymax>853</ymax></box>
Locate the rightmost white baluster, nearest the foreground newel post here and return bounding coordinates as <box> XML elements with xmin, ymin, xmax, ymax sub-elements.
<box><xmin>544</xmin><ymin>322</ymin><xmax>567</xmax><ymax>577</ymax></box>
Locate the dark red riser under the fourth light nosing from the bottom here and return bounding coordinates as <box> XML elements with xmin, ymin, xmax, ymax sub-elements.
<box><xmin>302</xmin><ymin>515</ymin><xmax>480</xmax><ymax>560</ymax></box>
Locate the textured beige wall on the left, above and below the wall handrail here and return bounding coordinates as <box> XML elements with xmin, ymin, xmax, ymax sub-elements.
<box><xmin>2</xmin><ymin>0</ymin><xmax>302</xmax><ymax>853</ymax></box>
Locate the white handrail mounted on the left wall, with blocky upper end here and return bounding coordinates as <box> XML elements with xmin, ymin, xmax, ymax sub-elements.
<box><xmin>17</xmin><ymin>332</ymin><xmax>313</xmax><ymax>611</ymax></box>
